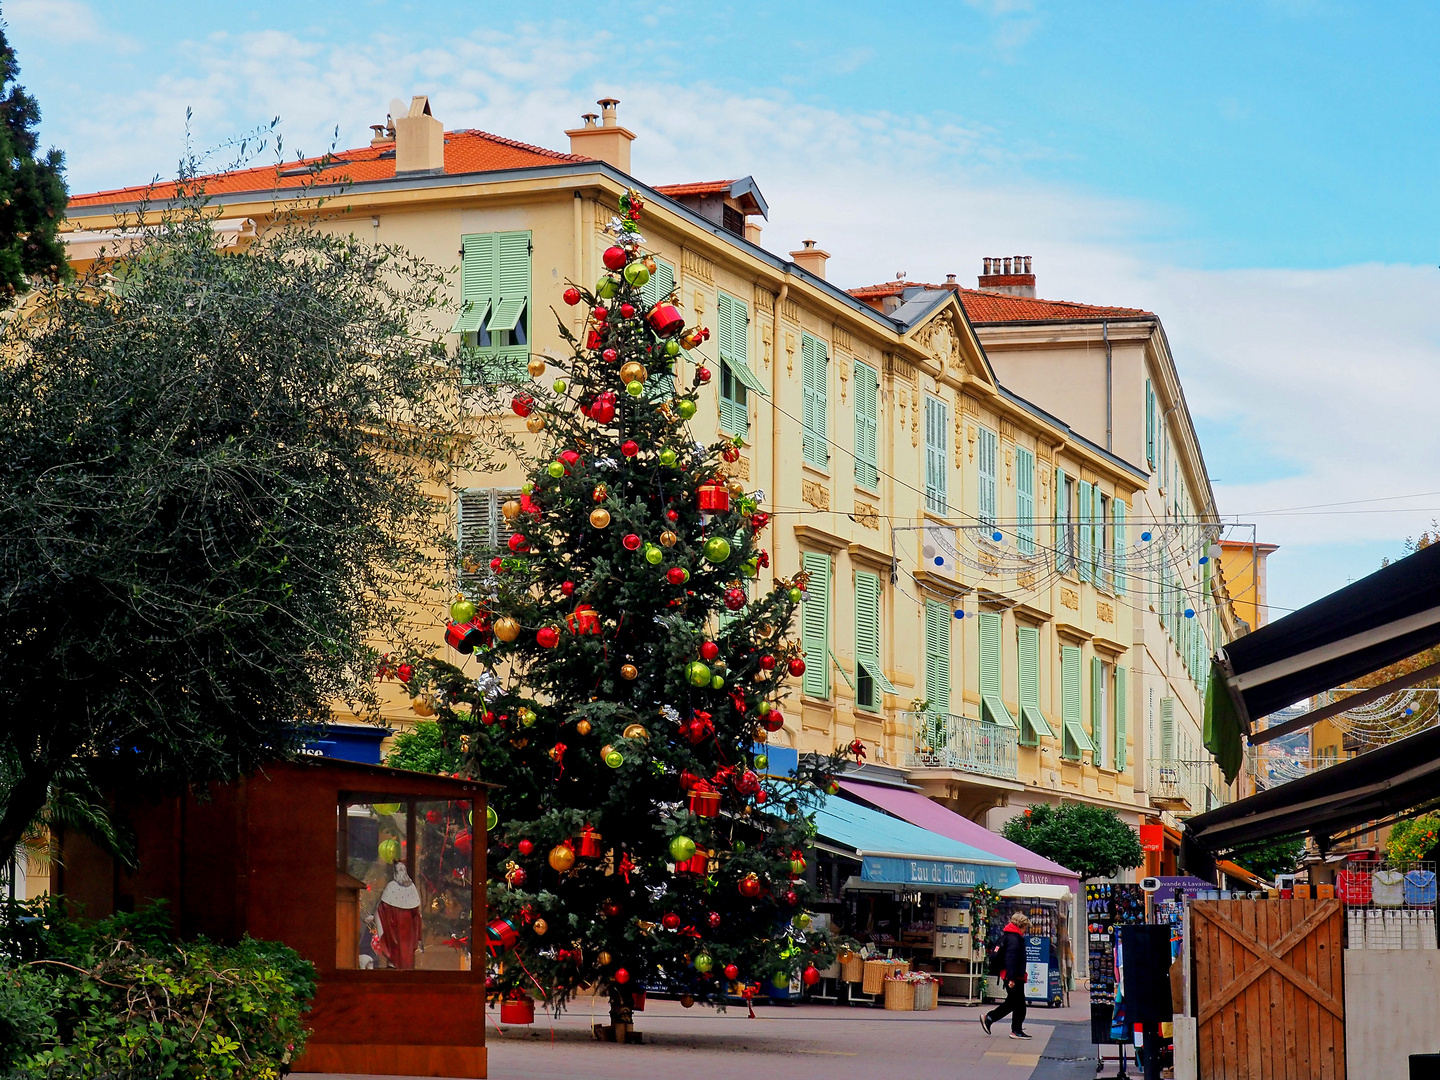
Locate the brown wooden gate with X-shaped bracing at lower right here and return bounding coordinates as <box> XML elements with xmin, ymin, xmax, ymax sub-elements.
<box><xmin>1189</xmin><ymin>900</ymin><xmax>1345</xmax><ymax>1080</ymax></box>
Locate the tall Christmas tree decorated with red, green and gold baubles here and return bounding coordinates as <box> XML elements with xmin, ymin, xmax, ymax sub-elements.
<box><xmin>405</xmin><ymin>192</ymin><xmax>841</xmax><ymax>1031</ymax></box>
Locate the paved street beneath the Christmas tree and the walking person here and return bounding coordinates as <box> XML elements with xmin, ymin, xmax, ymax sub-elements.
<box><xmin>318</xmin><ymin>996</ymin><xmax>1113</xmax><ymax>1080</ymax></box>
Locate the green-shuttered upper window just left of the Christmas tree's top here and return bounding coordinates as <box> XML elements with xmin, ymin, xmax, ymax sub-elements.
<box><xmin>451</xmin><ymin>232</ymin><xmax>531</xmax><ymax>382</ymax></box>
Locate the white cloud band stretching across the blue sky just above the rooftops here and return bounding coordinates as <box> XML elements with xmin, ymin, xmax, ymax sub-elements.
<box><xmin>50</xmin><ymin>21</ymin><xmax>1440</xmax><ymax>610</ymax></box>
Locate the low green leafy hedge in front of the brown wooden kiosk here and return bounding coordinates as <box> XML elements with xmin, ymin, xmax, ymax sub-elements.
<box><xmin>0</xmin><ymin>900</ymin><xmax>315</xmax><ymax>1080</ymax></box>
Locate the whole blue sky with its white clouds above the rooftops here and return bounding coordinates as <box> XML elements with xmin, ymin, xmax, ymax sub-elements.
<box><xmin>11</xmin><ymin>0</ymin><xmax>1440</xmax><ymax>613</ymax></box>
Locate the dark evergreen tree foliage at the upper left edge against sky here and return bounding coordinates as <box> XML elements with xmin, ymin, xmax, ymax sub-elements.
<box><xmin>0</xmin><ymin>29</ymin><xmax>69</xmax><ymax>307</ymax></box>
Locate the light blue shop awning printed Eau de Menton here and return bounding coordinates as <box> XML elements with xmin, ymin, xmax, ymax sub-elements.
<box><xmin>815</xmin><ymin>798</ymin><xmax>1020</xmax><ymax>891</ymax></box>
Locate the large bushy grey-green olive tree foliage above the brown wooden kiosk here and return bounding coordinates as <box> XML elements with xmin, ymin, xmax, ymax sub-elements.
<box><xmin>0</xmin><ymin>184</ymin><xmax>501</xmax><ymax>850</ymax></box>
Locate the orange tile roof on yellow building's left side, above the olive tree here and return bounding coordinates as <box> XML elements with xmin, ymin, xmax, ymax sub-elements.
<box><xmin>69</xmin><ymin>130</ymin><xmax>590</xmax><ymax>212</ymax></box>
